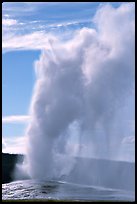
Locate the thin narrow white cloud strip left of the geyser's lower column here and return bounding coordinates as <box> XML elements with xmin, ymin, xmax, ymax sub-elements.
<box><xmin>2</xmin><ymin>115</ymin><xmax>30</xmax><ymax>123</ymax></box>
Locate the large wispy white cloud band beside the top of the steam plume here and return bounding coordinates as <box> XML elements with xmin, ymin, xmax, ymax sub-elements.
<box><xmin>2</xmin><ymin>19</ymin><xmax>91</xmax><ymax>53</ymax></box>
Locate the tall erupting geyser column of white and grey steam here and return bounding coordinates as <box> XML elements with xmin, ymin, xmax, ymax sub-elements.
<box><xmin>27</xmin><ymin>3</ymin><xmax>135</xmax><ymax>185</ymax></box>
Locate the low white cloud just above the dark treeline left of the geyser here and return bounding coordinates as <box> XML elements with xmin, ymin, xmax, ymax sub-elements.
<box><xmin>2</xmin><ymin>136</ymin><xmax>27</xmax><ymax>154</ymax></box>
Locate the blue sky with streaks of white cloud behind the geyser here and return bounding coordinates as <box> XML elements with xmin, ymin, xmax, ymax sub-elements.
<box><xmin>2</xmin><ymin>2</ymin><xmax>134</xmax><ymax>158</ymax></box>
